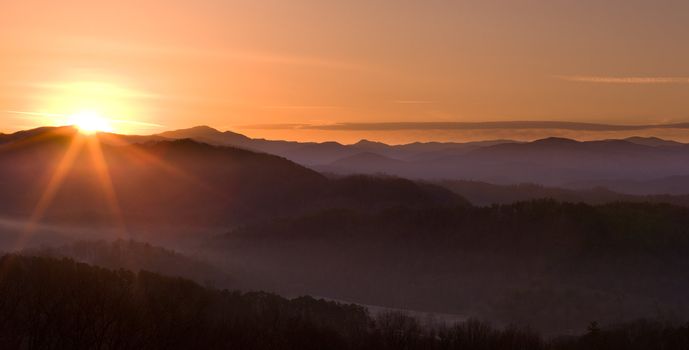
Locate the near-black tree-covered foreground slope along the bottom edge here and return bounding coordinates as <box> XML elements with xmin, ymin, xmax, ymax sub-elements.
<box><xmin>0</xmin><ymin>255</ymin><xmax>689</xmax><ymax>350</ymax></box>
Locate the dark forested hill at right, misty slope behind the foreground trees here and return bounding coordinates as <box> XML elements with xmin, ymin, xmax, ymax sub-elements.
<box><xmin>212</xmin><ymin>200</ymin><xmax>689</xmax><ymax>332</ymax></box>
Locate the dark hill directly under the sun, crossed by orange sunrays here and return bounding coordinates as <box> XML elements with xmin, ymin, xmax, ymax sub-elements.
<box><xmin>0</xmin><ymin>128</ymin><xmax>465</xmax><ymax>227</ymax></box>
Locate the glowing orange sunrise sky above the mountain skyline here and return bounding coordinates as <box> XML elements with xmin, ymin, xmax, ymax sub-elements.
<box><xmin>0</xmin><ymin>0</ymin><xmax>689</xmax><ymax>143</ymax></box>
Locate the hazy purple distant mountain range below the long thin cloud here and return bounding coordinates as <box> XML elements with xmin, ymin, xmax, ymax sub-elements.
<box><xmin>157</xmin><ymin>127</ymin><xmax>689</xmax><ymax>194</ymax></box>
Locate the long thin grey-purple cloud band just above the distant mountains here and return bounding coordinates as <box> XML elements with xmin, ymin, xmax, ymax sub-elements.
<box><xmin>242</xmin><ymin>121</ymin><xmax>689</xmax><ymax>131</ymax></box>
